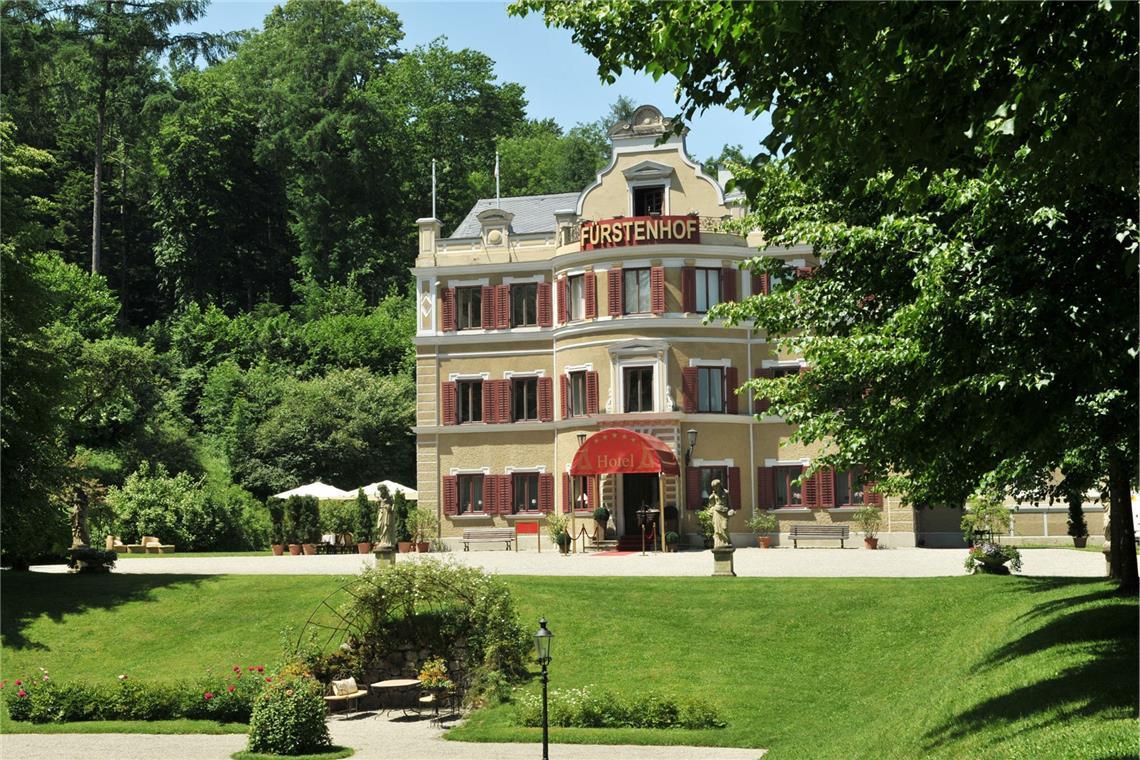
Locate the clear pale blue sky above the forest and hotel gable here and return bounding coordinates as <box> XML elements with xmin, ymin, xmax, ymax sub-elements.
<box><xmin>182</xmin><ymin>0</ymin><xmax>770</xmax><ymax>160</ymax></box>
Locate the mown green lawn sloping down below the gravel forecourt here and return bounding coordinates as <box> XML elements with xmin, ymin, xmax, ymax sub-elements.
<box><xmin>0</xmin><ymin>573</ymin><xmax>1140</xmax><ymax>760</ymax></box>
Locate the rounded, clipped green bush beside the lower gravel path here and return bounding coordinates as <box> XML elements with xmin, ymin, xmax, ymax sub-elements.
<box><xmin>243</xmin><ymin>675</ymin><xmax>332</xmax><ymax>754</ymax></box>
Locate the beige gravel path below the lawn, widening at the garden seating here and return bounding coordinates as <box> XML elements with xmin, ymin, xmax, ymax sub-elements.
<box><xmin>0</xmin><ymin>713</ymin><xmax>764</xmax><ymax>760</ymax></box>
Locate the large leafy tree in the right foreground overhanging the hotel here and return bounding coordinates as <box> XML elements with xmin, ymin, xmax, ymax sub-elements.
<box><xmin>512</xmin><ymin>0</ymin><xmax>1140</xmax><ymax>593</ymax></box>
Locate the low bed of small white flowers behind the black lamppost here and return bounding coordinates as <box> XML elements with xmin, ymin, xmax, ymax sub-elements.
<box><xmin>515</xmin><ymin>686</ymin><xmax>726</xmax><ymax>728</ymax></box>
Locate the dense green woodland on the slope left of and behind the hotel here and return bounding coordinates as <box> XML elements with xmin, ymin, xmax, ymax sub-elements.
<box><xmin>0</xmin><ymin>0</ymin><xmax>740</xmax><ymax>565</ymax></box>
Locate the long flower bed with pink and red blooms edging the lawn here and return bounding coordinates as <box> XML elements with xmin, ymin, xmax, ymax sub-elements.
<box><xmin>0</xmin><ymin>665</ymin><xmax>272</xmax><ymax>724</ymax></box>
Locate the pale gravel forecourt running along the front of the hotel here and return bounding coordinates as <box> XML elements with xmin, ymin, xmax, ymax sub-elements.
<box><xmin>33</xmin><ymin>547</ymin><xmax>1105</xmax><ymax>578</ymax></box>
